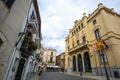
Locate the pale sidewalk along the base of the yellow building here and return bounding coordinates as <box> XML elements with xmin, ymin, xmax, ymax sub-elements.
<box><xmin>65</xmin><ymin>72</ymin><xmax>120</xmax><ymax>80</ymax></box>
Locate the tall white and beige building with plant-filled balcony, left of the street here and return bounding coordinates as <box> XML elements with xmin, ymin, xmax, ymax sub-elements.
<box><xmin>0</xmin><ymin>0</ymin><xmax>41</xmax><ymax>80</ymax></box>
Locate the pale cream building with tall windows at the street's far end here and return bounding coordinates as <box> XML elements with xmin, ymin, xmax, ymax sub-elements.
<box><xmin>39</xmin><ymin>45</ymin><xmax>56</xmax><ymax>71</ymax></box>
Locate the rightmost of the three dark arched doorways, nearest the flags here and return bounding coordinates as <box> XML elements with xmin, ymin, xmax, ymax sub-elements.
<box><xmin>84</xmin><ymin>52</ymin><xmax>91</xmax><ymax>72</ymax></box>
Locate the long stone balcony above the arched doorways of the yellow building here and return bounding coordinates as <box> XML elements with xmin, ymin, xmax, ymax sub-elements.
<box><xmin>68</xmin><ymin>42</ymin><xmax>88</xmax><ymax>53</ymax></box>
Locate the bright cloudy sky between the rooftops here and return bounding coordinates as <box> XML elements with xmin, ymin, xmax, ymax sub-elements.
<box><xmin>38</xmin><ymin>0</ymin><xmax>120</xmax><ymax>55</ymax></box>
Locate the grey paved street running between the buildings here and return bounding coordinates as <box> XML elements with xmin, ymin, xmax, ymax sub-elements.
<box><xmin>40</xmin><ymin>72</ymin><xmax>92</xmax><ymax>80</ymax></box>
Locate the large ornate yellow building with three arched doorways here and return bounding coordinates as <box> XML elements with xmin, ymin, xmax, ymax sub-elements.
<box><xmin>65</xmin><ymin>3</ymin><xmax>120</xmax><ymax>77</ymax></box>
